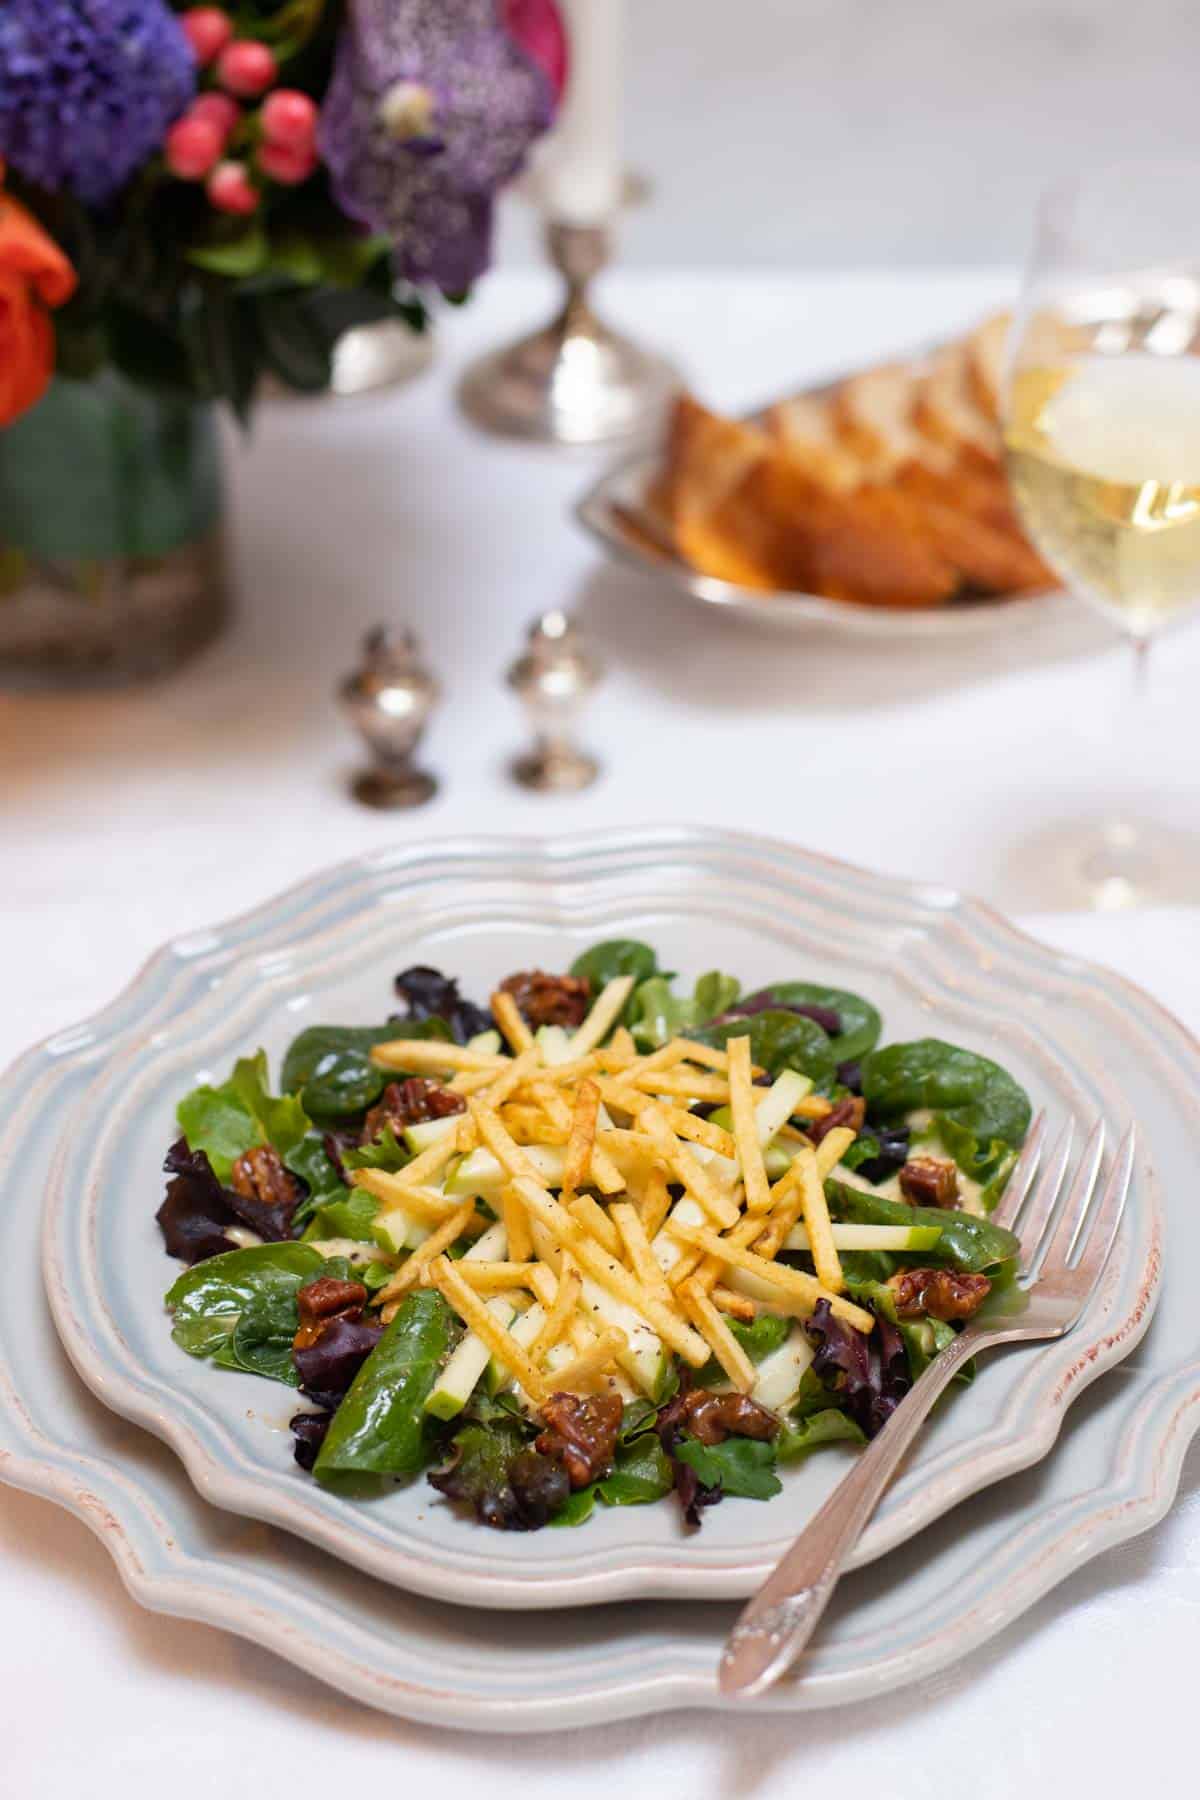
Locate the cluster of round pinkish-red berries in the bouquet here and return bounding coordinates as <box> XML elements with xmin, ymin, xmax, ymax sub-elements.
<box><xmin>164</xmin><ymin>5</ymin><xmax>317</xmax><ymax>214</ymax></box>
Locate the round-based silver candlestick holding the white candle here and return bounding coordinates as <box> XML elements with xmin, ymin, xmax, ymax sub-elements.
<box><xmin>459</xmin><ymin>223</ymin><xmax>680</xmax><ymax>445</ymax></box>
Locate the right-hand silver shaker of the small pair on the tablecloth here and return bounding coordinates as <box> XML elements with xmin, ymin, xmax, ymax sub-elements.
<box><xmin>507</xmin><ymin>612</ymin><xmax>603</xmax><ymax>794</ymax></box>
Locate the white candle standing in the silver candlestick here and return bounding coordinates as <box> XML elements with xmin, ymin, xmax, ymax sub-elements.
<box><xmin>536</xmin><ymin>0</ymin><xmax>624</xmax><ymax>225</ymax></box>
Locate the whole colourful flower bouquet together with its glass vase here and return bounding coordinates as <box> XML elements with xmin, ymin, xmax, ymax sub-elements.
<box><xmin>0</xmin><ymin>0</ymin><xmax>565</xmax><ymax>671</ymax></box>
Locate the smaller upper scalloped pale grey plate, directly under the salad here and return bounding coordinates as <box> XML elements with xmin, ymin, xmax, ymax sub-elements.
<box><xmin>35</xmin><ymin>830</ymin><xmax>1162</xmax><ymax>1607</ymax></box>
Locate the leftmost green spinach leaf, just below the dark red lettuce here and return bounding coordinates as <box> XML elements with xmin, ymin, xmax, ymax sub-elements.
<box><xmin>166</xmin><ymin>1244</ymin><xmax>333</xmax><ymax>1388</ymax></box>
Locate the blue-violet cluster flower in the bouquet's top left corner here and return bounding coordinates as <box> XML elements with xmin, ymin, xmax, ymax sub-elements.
<box><xmin>0</xmin><ymin>0</ymin><xmax>196</xmax><ymax>207</ymax></box>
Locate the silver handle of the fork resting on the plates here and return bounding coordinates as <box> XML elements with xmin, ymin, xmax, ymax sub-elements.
<box><xmin>720</xmin><ymin>1332</ymin><xmax>979</xmax><ymax>1699</ymax></box>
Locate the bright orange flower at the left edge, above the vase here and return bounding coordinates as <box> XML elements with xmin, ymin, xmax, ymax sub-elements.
<box><xmin>0</xmin><ymin>162</ymin><xmax>76</xmax><ymax>430</ymax></box>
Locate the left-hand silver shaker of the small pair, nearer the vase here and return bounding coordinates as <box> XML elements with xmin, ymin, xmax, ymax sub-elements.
<box><xmin>338</xmin><ymin>625</ymin><xmax>441</xmax><ymax>808</ymax></box>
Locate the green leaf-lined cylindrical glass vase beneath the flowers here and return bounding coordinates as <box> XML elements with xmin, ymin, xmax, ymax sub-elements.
<box><xmin>0</xmin><ymin>369</ymin><xmax>227</xmax><ymax>686</ymax></box>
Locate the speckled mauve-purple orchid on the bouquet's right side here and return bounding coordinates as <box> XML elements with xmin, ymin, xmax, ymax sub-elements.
<box><xmin>320</xmin><ymin>0</ymin><xmax>554</xmax><ymax>293</ymax></box>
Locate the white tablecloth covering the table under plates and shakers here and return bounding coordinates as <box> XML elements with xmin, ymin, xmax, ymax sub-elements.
<box><xmin>0</xmin><ymin>275</ymin><xmax>1200</xmax><ymax>1800</ymax></box>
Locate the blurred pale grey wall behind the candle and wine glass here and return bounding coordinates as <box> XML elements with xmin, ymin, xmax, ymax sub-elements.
<box><xmin>500</xmin><ymin>0</ymin><xmax>1200</xmax><ymax>268</ymax></box>
